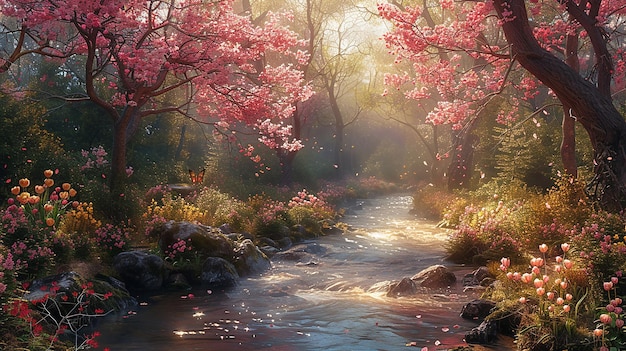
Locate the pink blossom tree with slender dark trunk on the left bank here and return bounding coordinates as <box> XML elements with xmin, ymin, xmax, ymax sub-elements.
<box><xmin>0</xmin><ymin>0</ymin><xmax>311</xmax><ymax>196</ymax></box>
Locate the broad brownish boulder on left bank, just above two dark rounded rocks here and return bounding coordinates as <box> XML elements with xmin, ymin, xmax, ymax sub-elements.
<box><xmin>159</xmin><ymin>221</ymin><xmax>234</xmax><ymax>259</ymax></box>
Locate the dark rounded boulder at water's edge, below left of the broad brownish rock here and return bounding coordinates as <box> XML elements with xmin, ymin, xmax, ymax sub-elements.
<box><xmin>113</xmin><ymin>251</ymin><xmax>169</xmax><ymax>291</ymax></box>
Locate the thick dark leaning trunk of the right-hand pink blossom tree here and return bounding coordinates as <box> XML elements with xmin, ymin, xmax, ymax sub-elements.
<box><xmin>494</xmin><ymin>0</ymin><xmax>626</xmax><ymax>210</ymax></box>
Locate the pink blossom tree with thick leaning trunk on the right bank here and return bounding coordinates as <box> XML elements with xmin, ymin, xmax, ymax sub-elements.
<box><xmin>379</xmin><ymin>0</ymin><xmax>626</xmax><ymax>209</ymax></box>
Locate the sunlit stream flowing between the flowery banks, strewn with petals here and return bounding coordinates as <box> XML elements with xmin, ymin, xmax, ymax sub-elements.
<box><xmin>98</xmin><ymin>195</ymin><xmax>508</xmax><ymax>351</ymax></box>
